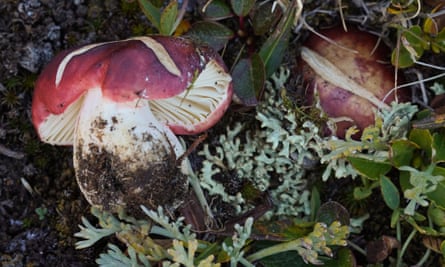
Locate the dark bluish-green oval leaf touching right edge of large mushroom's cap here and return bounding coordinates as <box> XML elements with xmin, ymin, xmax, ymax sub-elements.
<box><xmin>232</xmin><ymin>54</ymin><xmax>266</xmax><ymax>106</ymax></box>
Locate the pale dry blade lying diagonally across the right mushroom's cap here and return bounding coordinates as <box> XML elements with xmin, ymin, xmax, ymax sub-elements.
<box><xmin>301</xmin><ymin>46</ymin><xmax>389</xmax><ymax>109</ymax></box>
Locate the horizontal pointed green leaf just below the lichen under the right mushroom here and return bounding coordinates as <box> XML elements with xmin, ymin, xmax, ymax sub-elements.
<box><xmin>347</xmin><ymin>157</ymin><xmax>392</xmax><ymax>180</ymax></box>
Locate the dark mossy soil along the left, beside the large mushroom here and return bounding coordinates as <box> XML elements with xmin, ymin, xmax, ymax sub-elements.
<box><xmin>0</xmin><ymin>0</ymin><xmax>151</xmax><ymax>266</ymax></box>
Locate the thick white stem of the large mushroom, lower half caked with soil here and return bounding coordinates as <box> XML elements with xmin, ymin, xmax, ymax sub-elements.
<box><xmin>74</xmin><ymin>88</ymin><xmax>188</xmax><ymax>214</ymax></box>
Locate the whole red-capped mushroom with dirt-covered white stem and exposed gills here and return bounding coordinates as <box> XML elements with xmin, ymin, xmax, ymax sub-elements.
<box><xmin>32</xmin><ymin>36</ymin><xmax>232</xmax><ymax>216</ymax></box>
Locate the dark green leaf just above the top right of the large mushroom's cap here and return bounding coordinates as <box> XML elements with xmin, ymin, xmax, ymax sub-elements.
<box><xmin>187</xmin><ymin>21</ymin><xmax>234</xmax><ymax>51</ymax></box>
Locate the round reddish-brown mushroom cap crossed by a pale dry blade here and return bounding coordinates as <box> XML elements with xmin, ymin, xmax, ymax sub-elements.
<box><xmin>299</xmin><ymin>27</ymin><xmax>406</xmax><ymax>138</ymax></box>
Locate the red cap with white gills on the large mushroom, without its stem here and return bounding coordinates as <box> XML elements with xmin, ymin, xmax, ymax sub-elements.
<box><xmin>32</xmin><ymin>36</ymin><xmax>232</xmax><ymax>145</ymax></box>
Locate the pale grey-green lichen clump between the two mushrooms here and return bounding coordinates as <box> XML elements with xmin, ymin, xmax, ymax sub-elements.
<box><xmin>198</xmin><ymin>69</ymin><xmax>321</xmax><ymax>216</ymax></box>
